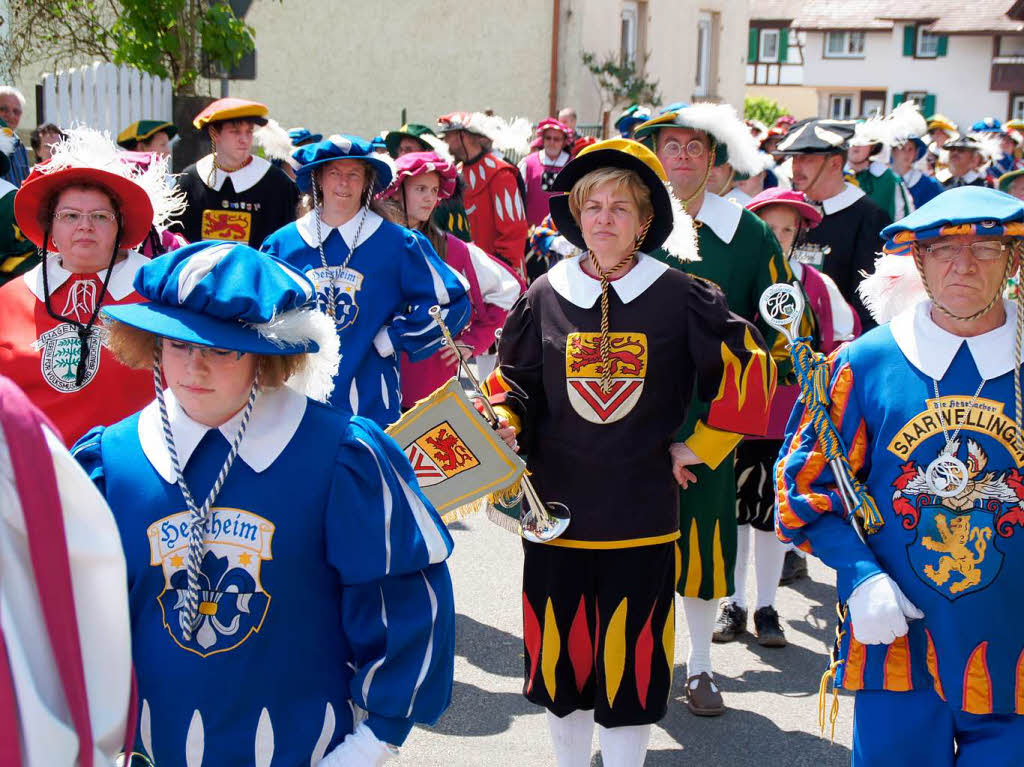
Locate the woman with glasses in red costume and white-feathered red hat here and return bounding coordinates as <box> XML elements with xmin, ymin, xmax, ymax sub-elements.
<box><xmin>0</xmin><ymin>130</ymin><xmax>153</xmax><ymax>445</ymax></box>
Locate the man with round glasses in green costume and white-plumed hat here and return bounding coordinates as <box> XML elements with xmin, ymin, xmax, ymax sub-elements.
<box><xmin>634</xmin><ymin>103</ymin><xmax>794</xmax><ymax>716</ymax></box>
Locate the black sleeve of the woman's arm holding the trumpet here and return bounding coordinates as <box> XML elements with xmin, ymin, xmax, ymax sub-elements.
<box><xmin>482</xmin><ymin>286</ymin><xmax>547</xmax><ymax>441</ymax></box>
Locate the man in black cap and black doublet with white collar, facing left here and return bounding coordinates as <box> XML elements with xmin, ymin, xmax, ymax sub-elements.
<box><xmin>777</xmin><ymin>118</ymin><xmax>892</xmax><ymax>330</ymax></box>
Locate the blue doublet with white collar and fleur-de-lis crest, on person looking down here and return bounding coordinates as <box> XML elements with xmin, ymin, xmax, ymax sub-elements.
<box><xmin>75</xmin><ymin>387</ymin><xmax>455</xmax><ymax>767</ymax></box>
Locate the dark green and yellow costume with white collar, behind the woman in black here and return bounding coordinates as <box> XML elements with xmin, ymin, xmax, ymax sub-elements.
<box><xmin>652</xmin><ymin>195</ymin><xmax>794</xmax><ymax>599</ymax></box>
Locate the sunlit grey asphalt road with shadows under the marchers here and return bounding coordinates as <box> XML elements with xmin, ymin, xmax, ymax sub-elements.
<box><xmin>391</xmin><ymin>514</ymin><xmax>853</xmax><ymax>767</ymax></box>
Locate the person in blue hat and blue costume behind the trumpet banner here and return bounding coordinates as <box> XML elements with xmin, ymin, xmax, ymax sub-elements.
<box><xmin>262</xmin><ymin>135</ymin><xmax>470</xmax><ymax>426</ymax></box>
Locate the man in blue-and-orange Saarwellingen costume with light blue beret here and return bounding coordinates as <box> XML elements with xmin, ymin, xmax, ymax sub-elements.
<box><xmin>775</xmin><ymin>186</ymin><xmax>1024</xmax><ymax>767</ymax></box>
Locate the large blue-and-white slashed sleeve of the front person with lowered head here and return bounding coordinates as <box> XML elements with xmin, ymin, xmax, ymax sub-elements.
<box><xmin>327</xmin><ymin>417</ymin><xmax>455</xmax><ymax>745</ymax></box>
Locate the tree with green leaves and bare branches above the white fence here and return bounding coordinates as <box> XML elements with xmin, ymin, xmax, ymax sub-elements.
<box><xmin>6</xmin><ymin>0</ymin><xmax>256</xmax><ymax>94</ymax></box>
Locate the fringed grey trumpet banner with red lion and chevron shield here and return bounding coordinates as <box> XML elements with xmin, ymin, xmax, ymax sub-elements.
<box><xmin>387</xmin><ymin>378</ymin><xmax>526</xmax><ymax>523</ymax></box>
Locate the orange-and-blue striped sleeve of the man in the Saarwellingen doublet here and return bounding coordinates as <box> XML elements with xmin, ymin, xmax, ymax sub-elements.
<box><xmin>775</xmin><ymin>346</ymin><xmax>882</xmax><ymax>601</ymax></box>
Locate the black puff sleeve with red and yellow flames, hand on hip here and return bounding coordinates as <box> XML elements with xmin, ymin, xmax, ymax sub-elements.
<box><xmin>685</xmin><ymin>279</ymin><xmax>776</xmax><ymax>468</ymax></box>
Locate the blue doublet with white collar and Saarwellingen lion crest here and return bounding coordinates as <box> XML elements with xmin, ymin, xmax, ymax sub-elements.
<box><xmin>776</xmin><ymin>302</ymin><xmax>1024</xmax><ymax>715</ymax></box>
